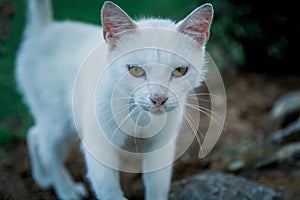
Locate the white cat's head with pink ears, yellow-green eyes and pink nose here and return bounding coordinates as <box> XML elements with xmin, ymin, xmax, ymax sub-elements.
<box><xmin>102</xmin><ymin>2</ymin><xmax>213</xmax><ymax>113</ymax></box>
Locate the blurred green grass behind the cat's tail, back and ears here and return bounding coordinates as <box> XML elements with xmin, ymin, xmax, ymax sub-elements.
<box><xmin>0</xmin><ymin>0</ymin><xmax>203</xmax><ymax>146</ymax></box>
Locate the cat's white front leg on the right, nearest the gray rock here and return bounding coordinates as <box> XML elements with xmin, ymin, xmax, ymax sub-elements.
<box><xmin>143</xmin><ymin>143</ymin><xmax>175</xmax><ymax>200</ymax></box>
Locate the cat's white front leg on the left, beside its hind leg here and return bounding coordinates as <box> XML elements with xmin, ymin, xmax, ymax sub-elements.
<box><xmin>84</xmin><ymin>150</ymin><xmax>126</xmax><ymax>200</ymax></box>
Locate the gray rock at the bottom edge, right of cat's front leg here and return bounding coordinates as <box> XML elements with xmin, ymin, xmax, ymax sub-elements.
<box><xmin>170</xmin><ymin>171</ymin><xmax>282</xmax><ymax>200</ymax></box>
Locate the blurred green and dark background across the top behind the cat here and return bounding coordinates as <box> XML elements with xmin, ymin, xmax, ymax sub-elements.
<box><xmin>0</xmin><ymin>0</ymin><xmax>300</xmax><ymax>146</ymax></box>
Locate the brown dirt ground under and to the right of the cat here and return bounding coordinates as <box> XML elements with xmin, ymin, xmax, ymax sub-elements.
<box><xmin>0</xmin><ymin>73</ymin><xmax>300</xmax><ymax>200</ymax></box>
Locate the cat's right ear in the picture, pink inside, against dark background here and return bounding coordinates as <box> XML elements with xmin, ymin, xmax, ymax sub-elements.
<box><xmin>177</xmin><ymin>3</ymin><xmax>214</xmax><ymax>45</ymax></box>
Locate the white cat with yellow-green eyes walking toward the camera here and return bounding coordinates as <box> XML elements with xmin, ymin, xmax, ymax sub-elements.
<box><xmin>16</xmin><ymin>0</ymin><xmax>213</xmax><ymax>200</ymax></box>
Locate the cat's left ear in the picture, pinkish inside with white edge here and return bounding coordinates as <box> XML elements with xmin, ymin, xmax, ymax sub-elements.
<box><xmin>101</xmin><ymin>1</ymin><xmax>137</xmax><ymax>48</ymax></box>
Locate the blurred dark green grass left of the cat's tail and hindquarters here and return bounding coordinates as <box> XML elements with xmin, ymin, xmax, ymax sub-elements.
<box><xmin>0</xmin><ymin>0</ymin><xmax>32</xmax><ymax>146</ymax></box>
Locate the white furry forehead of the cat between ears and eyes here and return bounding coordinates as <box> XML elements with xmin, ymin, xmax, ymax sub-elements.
<box><xmin>109</xmin><ymin>28</ymin><xmax>204</xmax><ymax>65</ymax></box>
